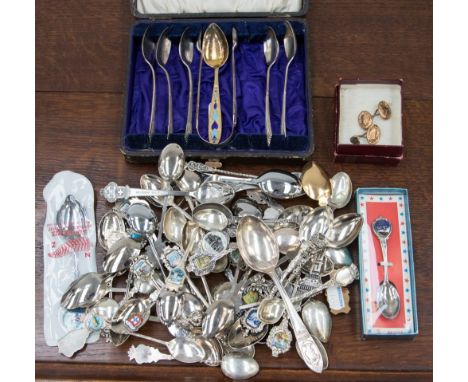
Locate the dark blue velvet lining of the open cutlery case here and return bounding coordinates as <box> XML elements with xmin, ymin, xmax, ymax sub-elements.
<box><xmin>122</xmin><ymin>21</ymin><xmax>311</xmax><ymax>153</ymax></box>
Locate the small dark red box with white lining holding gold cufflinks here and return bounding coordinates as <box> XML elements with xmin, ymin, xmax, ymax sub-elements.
<box><xmin>335</xmin><ymin>79</ymin><xmax>403</xmax><ymax>164</ymax></box>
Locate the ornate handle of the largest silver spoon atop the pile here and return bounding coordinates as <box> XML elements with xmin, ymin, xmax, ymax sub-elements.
<box><xmin>268</xmin><ymin>271</ymin><xmax>324</xmax><ymax>373</ymax></box>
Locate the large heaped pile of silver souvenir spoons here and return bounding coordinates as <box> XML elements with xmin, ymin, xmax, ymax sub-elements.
<box><xmin>59</xmin><ymin>144</ymin><xmax>362</xmax><ymax>379</ymax></box>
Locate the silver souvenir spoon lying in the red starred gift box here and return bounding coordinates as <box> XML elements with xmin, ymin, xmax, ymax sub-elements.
<box><xmin>372</xmin><ymin>217</ymin><xmax>400</xmax><ymax>320</ymax></box>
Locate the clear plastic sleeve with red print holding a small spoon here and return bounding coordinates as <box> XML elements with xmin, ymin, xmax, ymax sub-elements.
<box><xmin>43</xmin><ymin>171</ymin><xmax>99</xmax><ymax>346</ymax></box>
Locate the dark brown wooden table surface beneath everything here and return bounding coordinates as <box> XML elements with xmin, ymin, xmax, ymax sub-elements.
<box><xmin>36</xmin><ymin>0</ymin><xmax>432</xmax><ymax>381</ymax></box>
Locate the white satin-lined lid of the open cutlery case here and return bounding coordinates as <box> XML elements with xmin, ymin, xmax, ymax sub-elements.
<box><xmin>130</xmin><ymin>0</ymin><xmax>309</xmax><ymax>19</ymax></box>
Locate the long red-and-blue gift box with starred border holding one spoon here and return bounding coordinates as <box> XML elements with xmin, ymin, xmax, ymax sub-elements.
<box><xmin>356</xmin><ymin>188</ymin><xmax>418</xmax><ymax>337</ymax></box>
